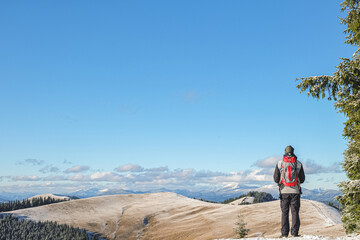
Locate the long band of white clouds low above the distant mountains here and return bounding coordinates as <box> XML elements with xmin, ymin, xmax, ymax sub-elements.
<box><xmin>3</xmin><ymin>156</ymin><xmax>340</xmax><ymax>194</ymax></box>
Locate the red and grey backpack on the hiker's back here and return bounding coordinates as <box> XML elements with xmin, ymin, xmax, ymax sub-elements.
<box><xmin>280</xmin><ymin>156</ymin><xmax>299</xmax><ymax>187</ymax></box>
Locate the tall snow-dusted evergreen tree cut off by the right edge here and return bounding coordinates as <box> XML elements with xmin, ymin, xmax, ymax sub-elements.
<box><xmin>297</xmin><ymin>0</ymin><xmax>360</xmax><ymax>233</ymax></box>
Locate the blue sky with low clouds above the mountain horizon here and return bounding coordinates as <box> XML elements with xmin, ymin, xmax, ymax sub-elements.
<box><xmin>0</xmin><ymin>0</ymin><xmax>355</xmax><ymax>191</ymax></box>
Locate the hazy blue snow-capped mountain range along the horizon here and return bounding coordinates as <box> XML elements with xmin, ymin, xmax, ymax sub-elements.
<box><xmin>0</xmin><ymin>185</ymin><xmax>341</xmax><ymax>203</ymax></box>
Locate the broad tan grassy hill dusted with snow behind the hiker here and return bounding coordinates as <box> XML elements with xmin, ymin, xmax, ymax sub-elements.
<box><xmin>7</xmin><ymin>193</ymin><xmax>345</xmax><ymax>240</ymax></box>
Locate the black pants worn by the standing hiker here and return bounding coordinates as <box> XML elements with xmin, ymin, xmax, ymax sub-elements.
<box><xmin>280</xmin><ymin>194</ymin><xmax>300</xmax><ymax>236</ymax></box>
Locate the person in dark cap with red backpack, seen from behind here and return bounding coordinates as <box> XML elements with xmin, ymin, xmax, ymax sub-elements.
<box><xmin>274</xmin><ymin>145</ymin><xmax>305</xmax><ymax>237</ymax></box>
